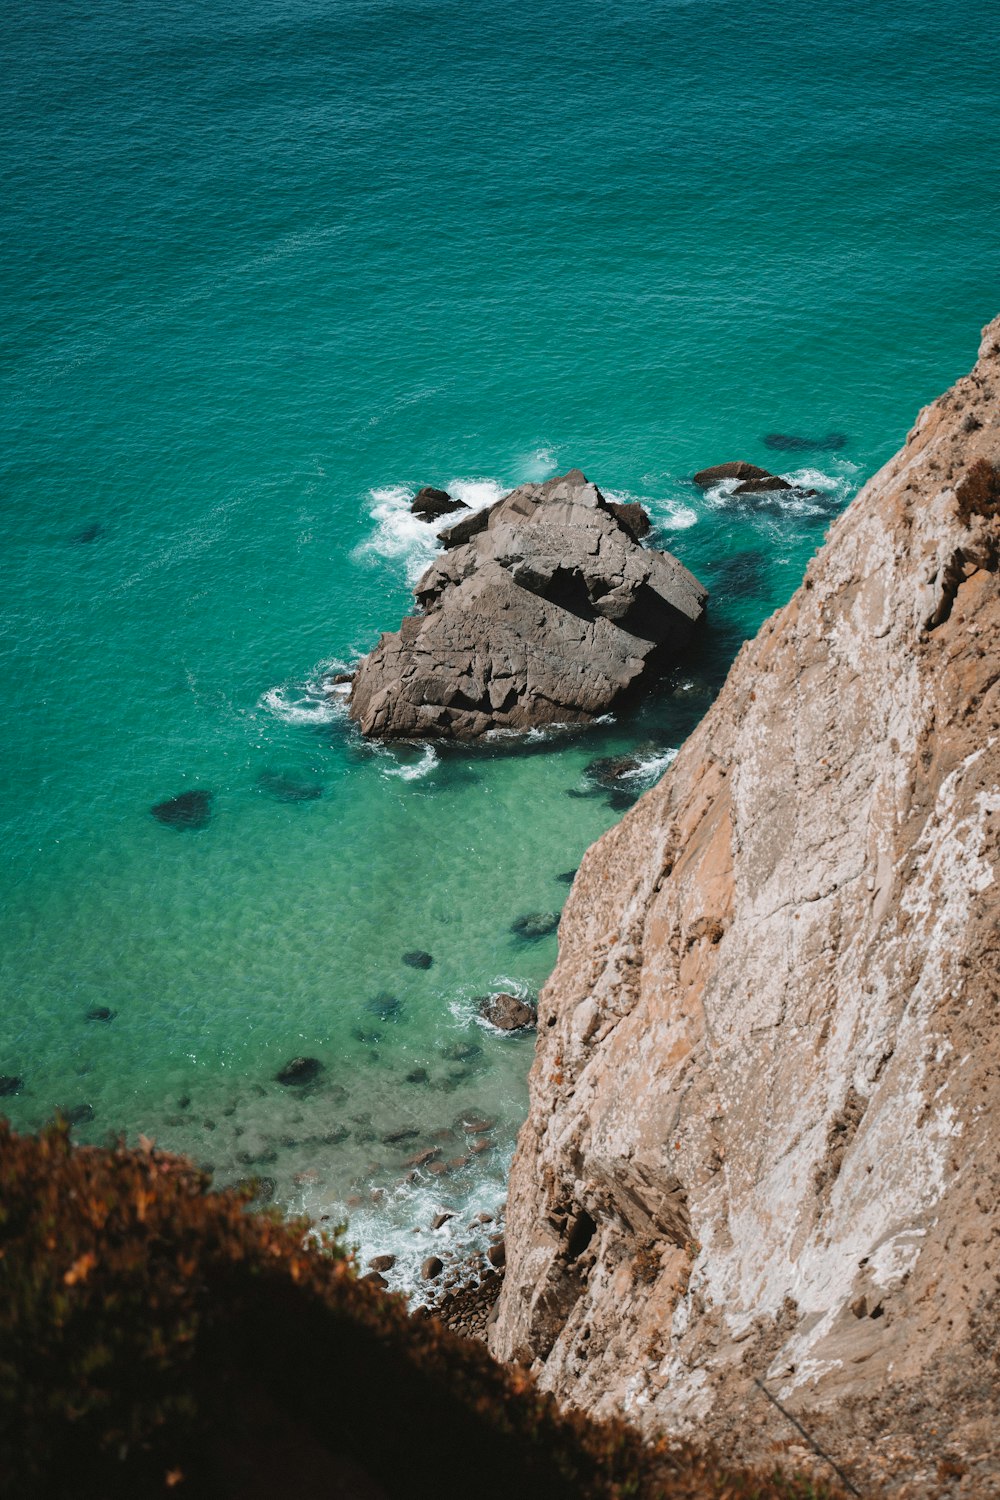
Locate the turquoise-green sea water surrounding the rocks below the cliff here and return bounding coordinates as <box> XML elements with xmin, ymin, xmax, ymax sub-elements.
<box><xmin>0</xmin><ymin>0</ymin><xmax>1000</xmax><ymax>1283</ymax></box>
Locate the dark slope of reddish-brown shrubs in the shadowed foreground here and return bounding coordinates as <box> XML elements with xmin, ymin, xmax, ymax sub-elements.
<box><xmin>0</xmin><ymin>1119</ymin><xmax>832</xmax><ymax>1500</ymax></box>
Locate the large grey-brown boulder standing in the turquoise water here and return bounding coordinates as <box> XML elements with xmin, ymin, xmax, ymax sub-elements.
<box><xmin>349</xmin><ymin>470</ymin><xmax>706</xmax><ymax>740</ymax></box>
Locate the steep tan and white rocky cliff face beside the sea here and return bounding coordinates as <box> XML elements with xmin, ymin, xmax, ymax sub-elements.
<box><xmin>490</xmin><ymin>318</ymin><xmax>1000</xmax><ymax>1488</ymax></box>
